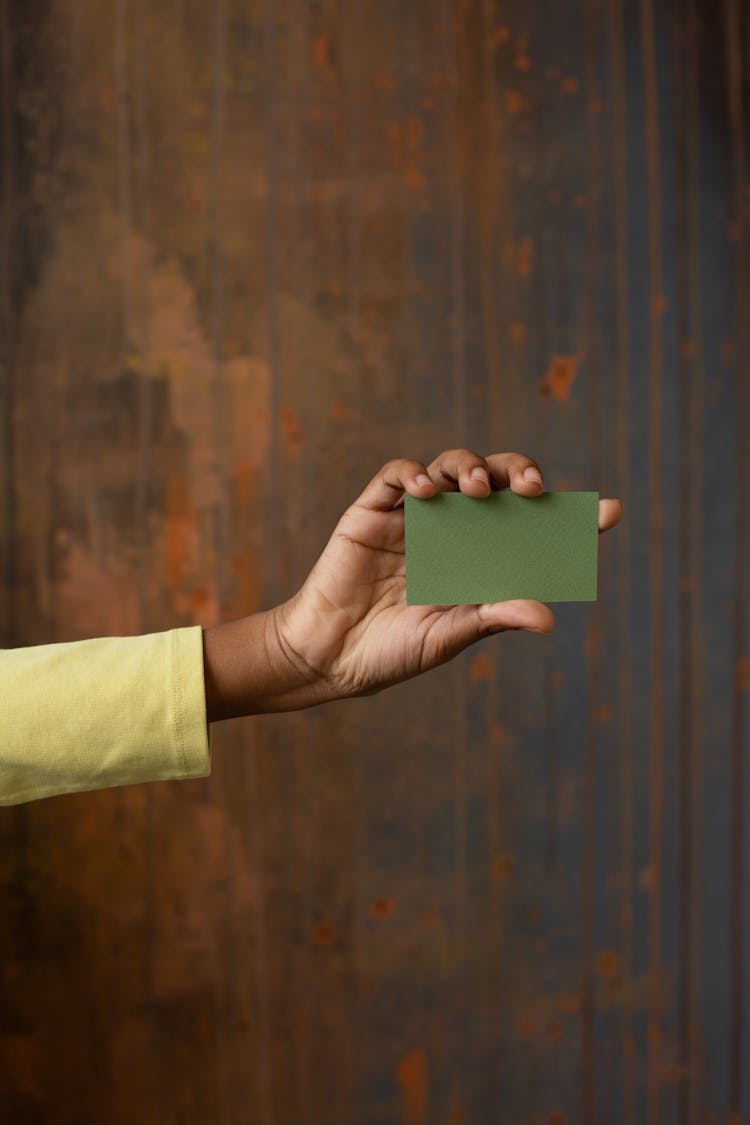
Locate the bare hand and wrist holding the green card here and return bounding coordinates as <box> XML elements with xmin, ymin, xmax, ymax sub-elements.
<box><xmin>204</xmin><ymin>449</ymin><xmax>622</xmax><ymax>722</ymax></box>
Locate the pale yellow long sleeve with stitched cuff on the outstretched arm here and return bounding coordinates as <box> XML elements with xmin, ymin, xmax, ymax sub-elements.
<box><xmin>0</xmin><ymin>626</ymin><xmax>211</xmax><ymax>804</ymax></box>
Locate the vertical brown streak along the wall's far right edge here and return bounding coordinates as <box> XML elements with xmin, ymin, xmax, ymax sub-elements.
<box><xmin>726</xmin><ymin>0</ymin><xmax>750</xmax><ymax>1111</ymax></box>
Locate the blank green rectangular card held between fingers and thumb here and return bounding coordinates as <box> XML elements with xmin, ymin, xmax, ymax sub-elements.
<box><xmin>404</xmin><ymin>492</ymin><xmax>599</xmax><ymax>605</ymax></box>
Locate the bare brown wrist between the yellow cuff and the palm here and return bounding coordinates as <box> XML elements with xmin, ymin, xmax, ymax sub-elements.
<box><xmin>204</xmin><ymin>605</ymin><xmax>324</xmax><ymax>722</ymax></box>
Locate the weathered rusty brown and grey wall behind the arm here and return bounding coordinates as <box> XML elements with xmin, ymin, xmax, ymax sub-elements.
<box><xmin>0</xmin><ymin>0</ymin><xmax>750</xmax><ymax>1125</ymax></box>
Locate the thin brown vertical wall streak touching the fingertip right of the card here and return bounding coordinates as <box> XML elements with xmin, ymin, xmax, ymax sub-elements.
<box><xmin>611</xmin><ymin>0</ymin><xmax>635</xmax><ymax>1125</ymax></box>
